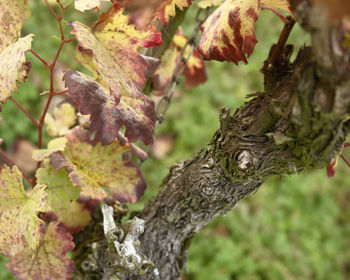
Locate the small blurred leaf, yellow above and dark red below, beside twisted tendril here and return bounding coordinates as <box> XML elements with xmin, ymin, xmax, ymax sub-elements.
<box><xmin>173</xmin><ymin>29</ymin><xmax>208</xmax><ymax>89</ymax></box>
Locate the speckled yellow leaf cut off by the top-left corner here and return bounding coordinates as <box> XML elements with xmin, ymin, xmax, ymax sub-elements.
<box><xmin>0</xmin><ymin>0</ymin><xmax>30</xmax><ymax>49</ymax></box>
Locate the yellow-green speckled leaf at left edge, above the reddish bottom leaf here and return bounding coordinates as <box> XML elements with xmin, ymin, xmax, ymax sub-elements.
<box><xmin>0</xmin><ymin>165</ymin><xmax>47</xmax><ymax>257</ymax></box>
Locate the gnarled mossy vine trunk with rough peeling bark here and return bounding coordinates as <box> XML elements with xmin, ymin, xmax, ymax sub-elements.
<box><xmin>72</xmin><ymin>1</ymin><xmax>350</xmax><ymax>280</ymax></box>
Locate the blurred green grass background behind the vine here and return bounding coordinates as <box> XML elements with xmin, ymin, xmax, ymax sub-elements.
<box><xmin>0</xmin><ymin>0</ymin><xmax>350</xmax><ymax>280</ymax></box>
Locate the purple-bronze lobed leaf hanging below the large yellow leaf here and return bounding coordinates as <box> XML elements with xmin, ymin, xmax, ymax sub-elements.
<box><xmin>64</xmin><ymin>70</ymin><xmax>155</xmax><ymax>145</ymax></box>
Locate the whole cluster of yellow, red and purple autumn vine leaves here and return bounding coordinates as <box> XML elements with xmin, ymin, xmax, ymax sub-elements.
<box><xmin>0</xmin><ymin>0</ymin><xmax>296</xmax><ymax>279</ymax></box>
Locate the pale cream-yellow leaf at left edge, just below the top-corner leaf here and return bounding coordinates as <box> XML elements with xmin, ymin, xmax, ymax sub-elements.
<box><xmin>0</xmin><ymin>34</ymin><xmax>33</xmax><ymax>104</ymax></box>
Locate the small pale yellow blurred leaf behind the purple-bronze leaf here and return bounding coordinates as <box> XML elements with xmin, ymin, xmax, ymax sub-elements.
<box><xmin>45</xmin><ymin>103</ymin><xmax>77</xmax><ymax>137</ymax></box>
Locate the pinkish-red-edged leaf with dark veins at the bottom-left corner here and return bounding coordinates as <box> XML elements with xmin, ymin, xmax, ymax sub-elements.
<box><xmin>7</xmin><ymin>223</ymin><xmax>74</xmax><ymax>280</ymax></box>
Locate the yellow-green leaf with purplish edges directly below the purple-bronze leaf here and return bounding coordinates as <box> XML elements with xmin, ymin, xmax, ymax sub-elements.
<box><xmin>51</xmin><ymin>129</ymin><xmax>145</xmax><ymax>202</ymax></box>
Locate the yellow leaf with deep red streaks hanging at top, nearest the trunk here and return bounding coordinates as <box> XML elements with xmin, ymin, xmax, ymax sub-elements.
<box><xmin>199</xmin><ymin>0</ymin><xmax>260</xmax><ymax>64</ymax></box>
